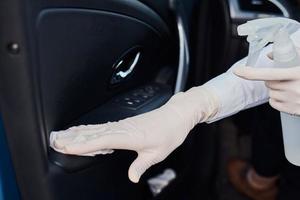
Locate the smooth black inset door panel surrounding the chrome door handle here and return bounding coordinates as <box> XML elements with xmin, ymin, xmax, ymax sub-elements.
<box><xmin>37</xmin><ymin>9</ymin><xmax>164</xmax><ymax>132</ymax></box>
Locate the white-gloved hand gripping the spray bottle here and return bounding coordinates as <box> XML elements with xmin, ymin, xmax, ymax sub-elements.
<box><xmin>234</xmin><ymin>66</ymin><xmax>300</xmax><ymax>115</ymax></box>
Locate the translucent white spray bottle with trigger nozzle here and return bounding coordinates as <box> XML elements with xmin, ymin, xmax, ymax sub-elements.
<box><xmin>238</xmin><ymin>18</ymin><xmax>300</xmax><ymax>166</ymax></box>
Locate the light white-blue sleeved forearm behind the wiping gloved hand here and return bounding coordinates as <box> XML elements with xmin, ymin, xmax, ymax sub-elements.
<box><xmin>203</xmin><ymin>56</ymin><xmax>269</xmax><ymax>123</ymax></box>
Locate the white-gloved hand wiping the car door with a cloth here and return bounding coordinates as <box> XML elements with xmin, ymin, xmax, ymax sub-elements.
<box><xmin>50</xmin><ymin>86</ymin><xmax>219</xmax><ymax>182</ymax></box>
